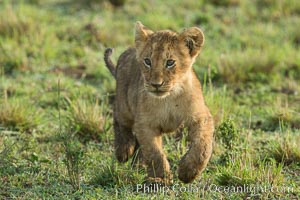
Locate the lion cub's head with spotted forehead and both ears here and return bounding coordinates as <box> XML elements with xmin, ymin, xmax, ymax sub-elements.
<box><xmin>135</xmin><ymin>22</ymin><xmax>204</xmax><ymax>98</ymax></box>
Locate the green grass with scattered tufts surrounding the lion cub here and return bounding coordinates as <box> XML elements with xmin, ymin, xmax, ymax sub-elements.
<box><xmin>0</xmin><ymin>0</ymin><xmax>300</xmax><ymax>199</ymax></box>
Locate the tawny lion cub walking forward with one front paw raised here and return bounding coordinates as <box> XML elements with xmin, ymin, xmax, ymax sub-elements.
<box><xmin>104</xmin><ymin>22</ymin><xmax>214</xmax><ymax>184</ymax></box>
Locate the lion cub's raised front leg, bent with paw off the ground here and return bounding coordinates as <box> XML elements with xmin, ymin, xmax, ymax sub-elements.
<box><xmin>178</xmin><ymin>110</ymin><xmax>214</xmax><ymax>183</ymax></box>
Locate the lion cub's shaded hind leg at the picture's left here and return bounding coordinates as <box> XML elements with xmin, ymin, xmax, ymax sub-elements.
<box><xmin>114</xmin><ymin>120</ymin><xmax>136</xmax><ymax>162</ymax></box>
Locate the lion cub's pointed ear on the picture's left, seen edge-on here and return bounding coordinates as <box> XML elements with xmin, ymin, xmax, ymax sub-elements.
<box><xmin>135</xmin><ymin>21</ymin><xmax>153</xmax><ymax>50</ymax></box>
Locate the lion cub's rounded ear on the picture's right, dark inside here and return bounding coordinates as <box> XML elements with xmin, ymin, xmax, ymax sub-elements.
<box><xmin>179</xmin><ymin>27</ymin><xmax>204</xmax><ymax>57</ymax></box>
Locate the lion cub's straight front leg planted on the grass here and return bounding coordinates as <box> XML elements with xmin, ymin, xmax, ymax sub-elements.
<box><xmin>134</xmin><ymin>125</ymin><xmax>172</xmax><ymax>184</ymax></box>
